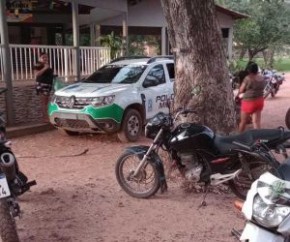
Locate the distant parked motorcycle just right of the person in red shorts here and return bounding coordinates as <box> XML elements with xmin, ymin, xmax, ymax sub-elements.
<box><xmin>263</xmin><ymin>70</ymin><xmax>285</xmax><ymax>98</ymax></box>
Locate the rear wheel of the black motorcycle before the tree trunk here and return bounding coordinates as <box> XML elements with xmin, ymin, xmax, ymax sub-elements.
<box><xmin>229</xmin><ymin>160</ymin><xmax>278</xmax><ymax>200</ymax></box>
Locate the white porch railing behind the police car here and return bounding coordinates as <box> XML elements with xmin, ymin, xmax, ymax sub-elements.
<box><xmin>0</xmin><ymin>44</ymin><xmax>110</xmax><ymax>81</ymax></box>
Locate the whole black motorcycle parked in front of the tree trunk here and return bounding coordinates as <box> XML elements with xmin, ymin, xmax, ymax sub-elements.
<box><xmin>115</xmin><ymin>110</ymin><xmax>290</xmax><ymax>199</ymax></box>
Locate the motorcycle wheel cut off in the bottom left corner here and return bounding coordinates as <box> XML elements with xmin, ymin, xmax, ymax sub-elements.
<box><xmin>0</xmin><ymin>199</ymin><xmax>19</xmax><ymax>242</ymax></box>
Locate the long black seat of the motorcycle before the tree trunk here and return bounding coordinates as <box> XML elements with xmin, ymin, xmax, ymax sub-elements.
<box><xmin>214</xmin><ymin>129</ymin><xmax>284</xmax><ymax>154</ymax></box>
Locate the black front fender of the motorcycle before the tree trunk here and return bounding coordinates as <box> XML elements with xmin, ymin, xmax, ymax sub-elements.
<box><xmin>126</xmin><ymin>145</ymin><xmax>167</xmax><ymax>193</ymax></box>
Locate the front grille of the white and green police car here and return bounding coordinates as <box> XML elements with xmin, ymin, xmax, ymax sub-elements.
<box><xmin>55</xmin><ymin>96</ymin><xmax>92</xmax><ymax>109</ymax></box>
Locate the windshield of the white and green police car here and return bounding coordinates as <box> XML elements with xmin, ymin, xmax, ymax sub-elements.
<box><xmin>84</xmin><ymin>65</ymin><xmax>146</xmax><ymax>84</ymax></box>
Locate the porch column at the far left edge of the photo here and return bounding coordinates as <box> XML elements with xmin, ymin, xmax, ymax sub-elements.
<box><xmin>0</xmin><ymin>0</ymin><xmax>14</xmax><ymax>126</ymax></box>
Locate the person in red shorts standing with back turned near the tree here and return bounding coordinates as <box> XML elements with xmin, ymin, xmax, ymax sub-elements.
<box><xmin>238</xmin><ymin>62</ymin><xmax>266</xmax><ymax>132</ymax></box>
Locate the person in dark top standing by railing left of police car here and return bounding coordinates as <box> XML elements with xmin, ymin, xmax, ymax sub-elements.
<box><xmin>34</xmin><ymin>53</ymin><xmax>53</xmax><ymax>122</ymax></box>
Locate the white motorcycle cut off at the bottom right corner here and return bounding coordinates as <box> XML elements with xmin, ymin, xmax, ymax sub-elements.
<box><xmin>232</xmin><ymin>142</ymin><xmax>290</xmax><ymax>242</ymax></box>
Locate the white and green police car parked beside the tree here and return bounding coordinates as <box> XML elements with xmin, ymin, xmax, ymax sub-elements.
<box><xmin>49</xmin><ymin>56</ymin><xmax>174</xmax><ymax>142</ymax></box>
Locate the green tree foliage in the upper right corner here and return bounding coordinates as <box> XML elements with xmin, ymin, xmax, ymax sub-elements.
<box><xmin>216</xmin><ymin>0</ymin><xmax>290</xmax><ymax>59</ymax></box>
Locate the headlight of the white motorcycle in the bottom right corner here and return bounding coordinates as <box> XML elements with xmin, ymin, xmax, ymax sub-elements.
<box><xmin>253</xmin><ymin>195</ymin><xmax>290</xmax><ymax>228</ymax></box>
